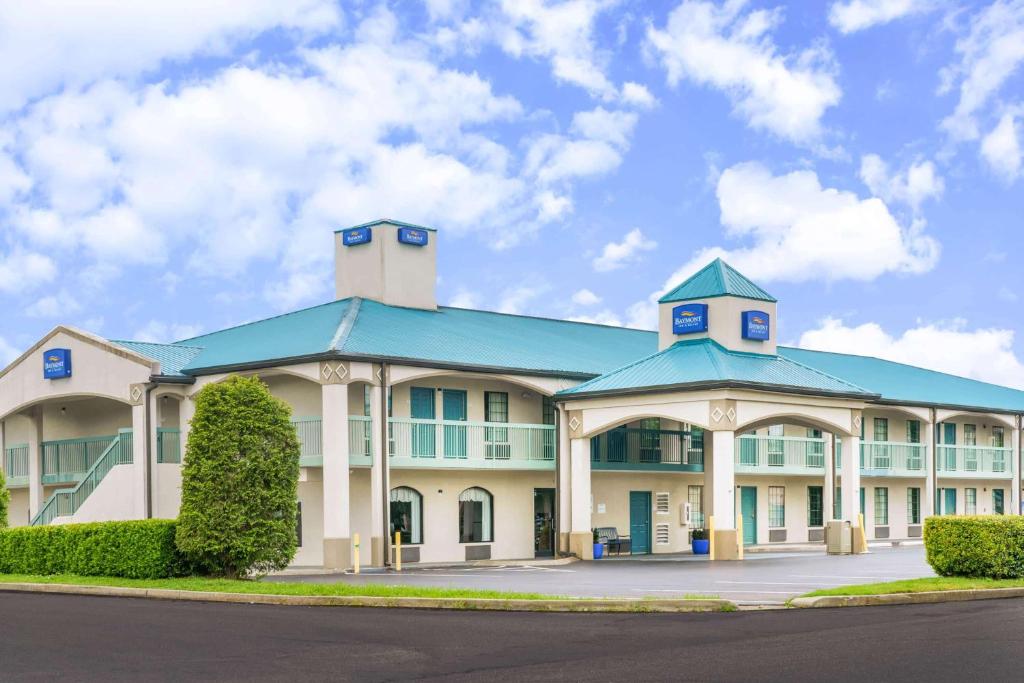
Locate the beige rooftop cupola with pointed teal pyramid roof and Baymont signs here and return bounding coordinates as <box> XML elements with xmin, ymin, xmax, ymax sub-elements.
<box><xmin>658</xmin><ymin>258</ymin><xmax>776</xmax><ymax>355</ymax></box>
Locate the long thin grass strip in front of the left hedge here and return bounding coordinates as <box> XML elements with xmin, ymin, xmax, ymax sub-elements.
<box><xmin>0</xmin><ymin>574</ymin><xmax>558</xmax><ymax>600</ymax></box>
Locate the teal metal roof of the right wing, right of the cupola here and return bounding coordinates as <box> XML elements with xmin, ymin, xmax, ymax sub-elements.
<box><xmin>778</xmin><ymin>346</ymin><xmax>1024</xmax><ymax>411</ymax></box>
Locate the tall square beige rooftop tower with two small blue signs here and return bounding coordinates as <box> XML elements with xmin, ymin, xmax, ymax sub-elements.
<box><xmin>334</xmin><ymin>218</ymin><xmax>437</xmax><ymax>310</ymax></box>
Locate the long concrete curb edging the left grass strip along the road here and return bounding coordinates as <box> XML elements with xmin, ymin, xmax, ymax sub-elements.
<box><xmin>0</xmin><ymin>584</ymin><xmax>736</xmax><ymax>612</ymax></box>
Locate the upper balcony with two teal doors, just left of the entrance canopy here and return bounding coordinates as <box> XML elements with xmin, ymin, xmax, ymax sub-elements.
<box><xmin>388</xmin><ymin>418</ymin><xmax>555</xmax><ymax>470</ymax></box>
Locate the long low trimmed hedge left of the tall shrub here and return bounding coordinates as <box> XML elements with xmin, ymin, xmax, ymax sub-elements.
<box><xmin>0</xmin><ymin>519</ymin><xmax>187</xmax><ymax>579</ymax></box>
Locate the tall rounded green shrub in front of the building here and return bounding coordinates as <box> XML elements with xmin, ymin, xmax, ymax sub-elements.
<box><xmin>176</xmin><ymin>377</ymin><xmax>299</xmax><ymax>579</ymax></box>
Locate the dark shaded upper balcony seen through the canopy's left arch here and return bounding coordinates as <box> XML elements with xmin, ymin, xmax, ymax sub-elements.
<box><xmin>590</xmin><ymin>427</ymin><xmax>703</xmax><ymax>472</ymax></box>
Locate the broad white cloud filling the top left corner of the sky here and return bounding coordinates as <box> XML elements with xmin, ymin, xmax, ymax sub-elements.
<box><xmin>0</xmin><ymin>0</ymin><xmax>341</xmax><ymax>113</ymax></box>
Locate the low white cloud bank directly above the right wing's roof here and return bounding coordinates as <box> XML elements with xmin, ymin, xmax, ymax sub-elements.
<box><xmin>799</xmin><ymin>317</ymin><xmax>1024</xmax><ymax>388</ymax></box>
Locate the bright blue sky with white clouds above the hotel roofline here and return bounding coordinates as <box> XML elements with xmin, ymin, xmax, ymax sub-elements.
<box><xmin>0</xmin><ymin>0</ymin><xmax>1024</xmax><ymax>386</ymax></box>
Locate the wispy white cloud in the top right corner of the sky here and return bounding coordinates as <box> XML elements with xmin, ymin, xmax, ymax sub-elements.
<box><xmin>940</xmin><ymin>0</ymin><xmax>1024</xmax><ymax>140</ymax></box>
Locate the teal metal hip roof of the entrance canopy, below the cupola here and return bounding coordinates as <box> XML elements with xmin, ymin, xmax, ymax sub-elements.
<box><xmin>558</xmin><ymin>339</ymin><xmax>873</xmax><ymax>399</ymax></box>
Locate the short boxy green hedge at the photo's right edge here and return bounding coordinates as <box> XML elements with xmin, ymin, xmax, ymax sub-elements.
<box><xmin>925</xmin><ymin>515</ymin><xmax>1024</xmax><ymax>579</ymax></box>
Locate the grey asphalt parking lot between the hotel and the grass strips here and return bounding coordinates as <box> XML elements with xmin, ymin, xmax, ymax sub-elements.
<box><xmin>267</xmin><ymin>546</ymin><xmax>935</xmax><ymax>604</ymax></box>
